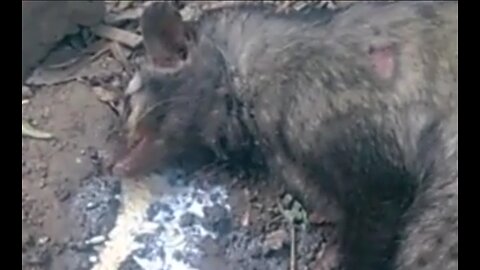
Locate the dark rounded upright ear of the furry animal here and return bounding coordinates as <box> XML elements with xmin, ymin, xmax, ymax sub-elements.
<box><xmin>140</xmin><ymin>2</ymin><xmax>195</xmax><ymax>68</ymax></box>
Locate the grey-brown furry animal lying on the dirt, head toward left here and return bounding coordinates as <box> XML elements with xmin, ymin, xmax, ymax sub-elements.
<box><xmin>116</xmin><ymin>2</ymin><xmax>458</xmax><ymax>270</ymax></box>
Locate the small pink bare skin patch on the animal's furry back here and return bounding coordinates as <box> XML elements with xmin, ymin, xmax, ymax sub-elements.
<box><xmin>369</xmin><ymin>44</ymin><xmax>396</xmax><ymax>80</ymax></box>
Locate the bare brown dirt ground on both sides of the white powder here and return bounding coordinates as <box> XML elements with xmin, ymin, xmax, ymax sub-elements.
<box><xmin>22</xmin><ymin>1</ymin><xmax>335</xmax><ymax>270</ymax></box>
